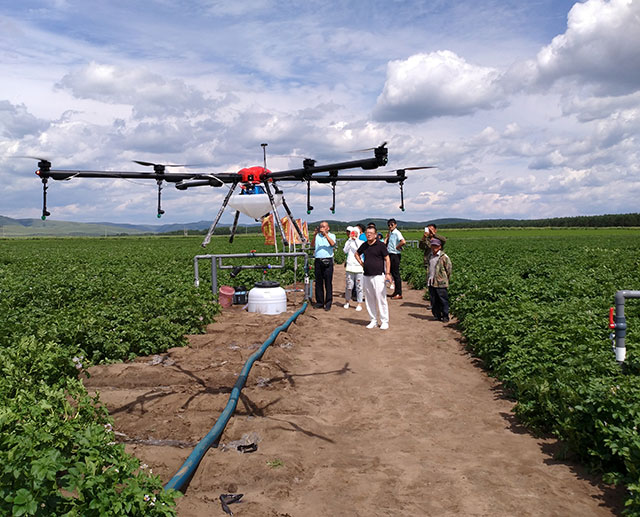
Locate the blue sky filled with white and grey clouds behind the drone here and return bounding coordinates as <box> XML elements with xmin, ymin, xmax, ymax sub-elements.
<box><xmin>0</xmin><ymin>0</ymin><xmax>640</xmax><ymax>224</ymax></box>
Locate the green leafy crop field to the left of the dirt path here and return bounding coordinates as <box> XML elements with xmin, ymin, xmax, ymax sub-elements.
<box><xmin>0</xmin><ymin>237</ymin><xmax>302</xmax><ymax>516</ymax></box>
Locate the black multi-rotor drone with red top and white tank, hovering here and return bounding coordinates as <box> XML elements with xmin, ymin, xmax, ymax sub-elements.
<box><xmin>28</xmin><ymin>142</ymin><xmax>432</xmax><ymax>247</ymax></box>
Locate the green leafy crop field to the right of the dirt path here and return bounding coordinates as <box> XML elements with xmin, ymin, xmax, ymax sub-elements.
<box><xmin>402</xmin><ymin>229</ymin><xmax>640</xmax><ymax>515</ymax></box>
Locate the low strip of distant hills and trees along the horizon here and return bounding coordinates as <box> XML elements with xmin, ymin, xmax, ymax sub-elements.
<box><xmin>0</xmin><ymin>213</ymin><xmax>640</xmax><ymax>238</ymax></box>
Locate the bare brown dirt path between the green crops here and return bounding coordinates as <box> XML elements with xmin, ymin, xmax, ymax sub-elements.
<box><xmin>87</xmin><ymin>267</ymin><xmax>622</xmax><ymax>517</ymax></box>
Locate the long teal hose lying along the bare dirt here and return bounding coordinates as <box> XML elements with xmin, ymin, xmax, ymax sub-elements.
<box><xmin>164</xmin><ymin>301</ymin><xmax>308</xmax><ymax>490</ymax></box>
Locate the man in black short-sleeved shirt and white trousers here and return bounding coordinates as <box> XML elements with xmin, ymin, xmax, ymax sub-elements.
<box><xmin>356</xmin><ymin>228</ymin><xmax>391</xmax><ymax>330</ymax></box>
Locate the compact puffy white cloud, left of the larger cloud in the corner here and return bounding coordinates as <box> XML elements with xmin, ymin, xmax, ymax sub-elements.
<box><xmin>374</xmin><ymin>50</ymin><xmax>504</xmax><ymax>121</ymax></box>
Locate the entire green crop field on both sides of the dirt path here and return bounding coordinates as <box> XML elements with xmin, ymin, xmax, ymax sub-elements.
<box><xmin>0</xmin><ymin>229</ymin><xmax>640</xmax><ymax>515</ymax></box>
